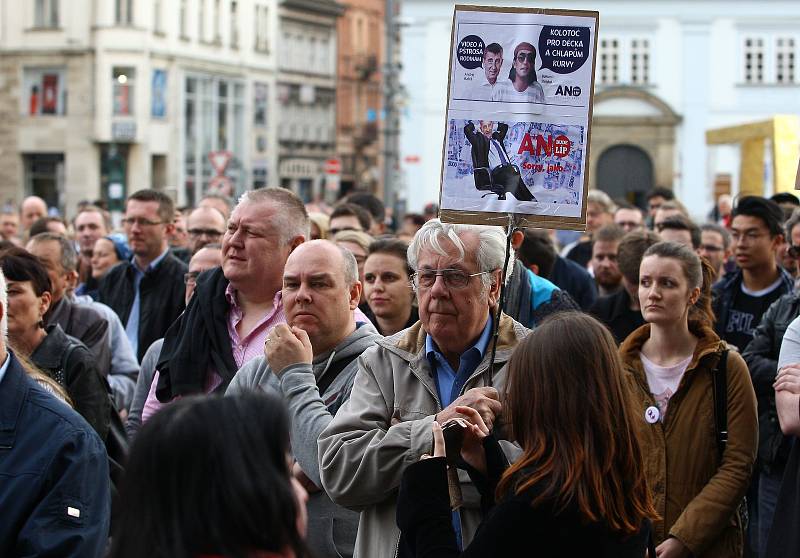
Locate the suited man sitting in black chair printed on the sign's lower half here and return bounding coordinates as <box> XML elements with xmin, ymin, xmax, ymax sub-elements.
<box><xmin>464</xmin><ymin>120</ymin><xmax>536</xmax><ymax>201</ymax></box>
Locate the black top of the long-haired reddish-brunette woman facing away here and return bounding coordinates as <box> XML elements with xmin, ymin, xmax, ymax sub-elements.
<box><xmin>397</xmin><ymin>437</ymin><xmax>649</xmax><ymax>558</ymax></box>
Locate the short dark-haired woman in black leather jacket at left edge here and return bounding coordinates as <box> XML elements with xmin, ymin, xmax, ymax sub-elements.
<box><xmin>0</xmin><ymin>252</ymin><xmax>111</xmax><ymax>440</ymax></box>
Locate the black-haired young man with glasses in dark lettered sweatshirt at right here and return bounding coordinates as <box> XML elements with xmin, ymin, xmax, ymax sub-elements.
<box><xmin>713</xmin><ymin>196</ymin><xmax>794</xmax><ymax>351</ymax></box>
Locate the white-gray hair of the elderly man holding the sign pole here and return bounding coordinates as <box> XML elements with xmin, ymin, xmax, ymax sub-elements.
<box><xmin>408</xmin><ymin>219</ymin><xmax>514</xmax><ymax>289</ymax></box>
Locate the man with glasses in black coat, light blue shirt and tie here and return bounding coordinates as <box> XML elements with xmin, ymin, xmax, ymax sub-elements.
<box><xmin>99</xmin><ymin>190</ymin><xmax>187</xmax><ymax>362</ymax></box>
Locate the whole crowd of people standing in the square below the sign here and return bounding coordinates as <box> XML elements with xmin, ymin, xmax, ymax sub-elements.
<box><xmin>0</xmin><ymin>188</ymin><xmax>800</xmax><ymax>558</ymax></box>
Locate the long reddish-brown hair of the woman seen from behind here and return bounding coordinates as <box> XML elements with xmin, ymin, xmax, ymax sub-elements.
<box><xmin>496</xmin><ymin>312</ymin><xmax>657</xmax><ymax>536</ymax></box>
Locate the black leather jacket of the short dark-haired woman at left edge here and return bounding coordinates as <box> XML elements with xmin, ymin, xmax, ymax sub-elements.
<box><xmin>30</xmin><ymin>324</ymin><xmax>111</xmax><ymax>440</ymax></box>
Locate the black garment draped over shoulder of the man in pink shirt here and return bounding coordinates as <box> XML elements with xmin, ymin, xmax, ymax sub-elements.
<box><xmin>156</xmin><ymin>267</ymin><xmax>239</xmax><ymax>403</ymax></box>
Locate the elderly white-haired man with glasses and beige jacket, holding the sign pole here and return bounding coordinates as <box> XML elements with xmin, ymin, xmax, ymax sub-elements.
<box><xmin>319</xmin><ymin>219</ymin><xmax>528</xmax><ymax>558</ymax></box>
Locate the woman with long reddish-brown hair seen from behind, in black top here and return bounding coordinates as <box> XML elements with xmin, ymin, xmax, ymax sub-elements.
<box><xmin>397</xmin><ymin>313</ymin><xmax>655</xmax><ymax>558</ymax></box>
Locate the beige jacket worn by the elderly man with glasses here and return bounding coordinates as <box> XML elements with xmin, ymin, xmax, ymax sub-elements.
<box><xmin>318</xmin><ymin>315</ymin><xmax>529</xmax><ymax>558</ymax></box>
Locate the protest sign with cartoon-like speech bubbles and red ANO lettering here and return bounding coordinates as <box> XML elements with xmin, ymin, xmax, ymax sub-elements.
<box><xmin>439</xmin><ymin>6</ymin><xmax>599</xmax><ymax>230</ymax></box>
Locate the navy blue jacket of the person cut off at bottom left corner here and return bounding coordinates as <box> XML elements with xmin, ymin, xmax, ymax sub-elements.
<box><xmin>0</xmin><ymin>352</ymin><xmax>111</xmax><ymax>558</ymax></box>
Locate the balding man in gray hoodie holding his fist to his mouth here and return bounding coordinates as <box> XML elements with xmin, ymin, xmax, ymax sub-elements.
<box><xmin>226</xmin><ymin>240</ymin><xmax>380</xmax><ymax>558</ymax></box>
